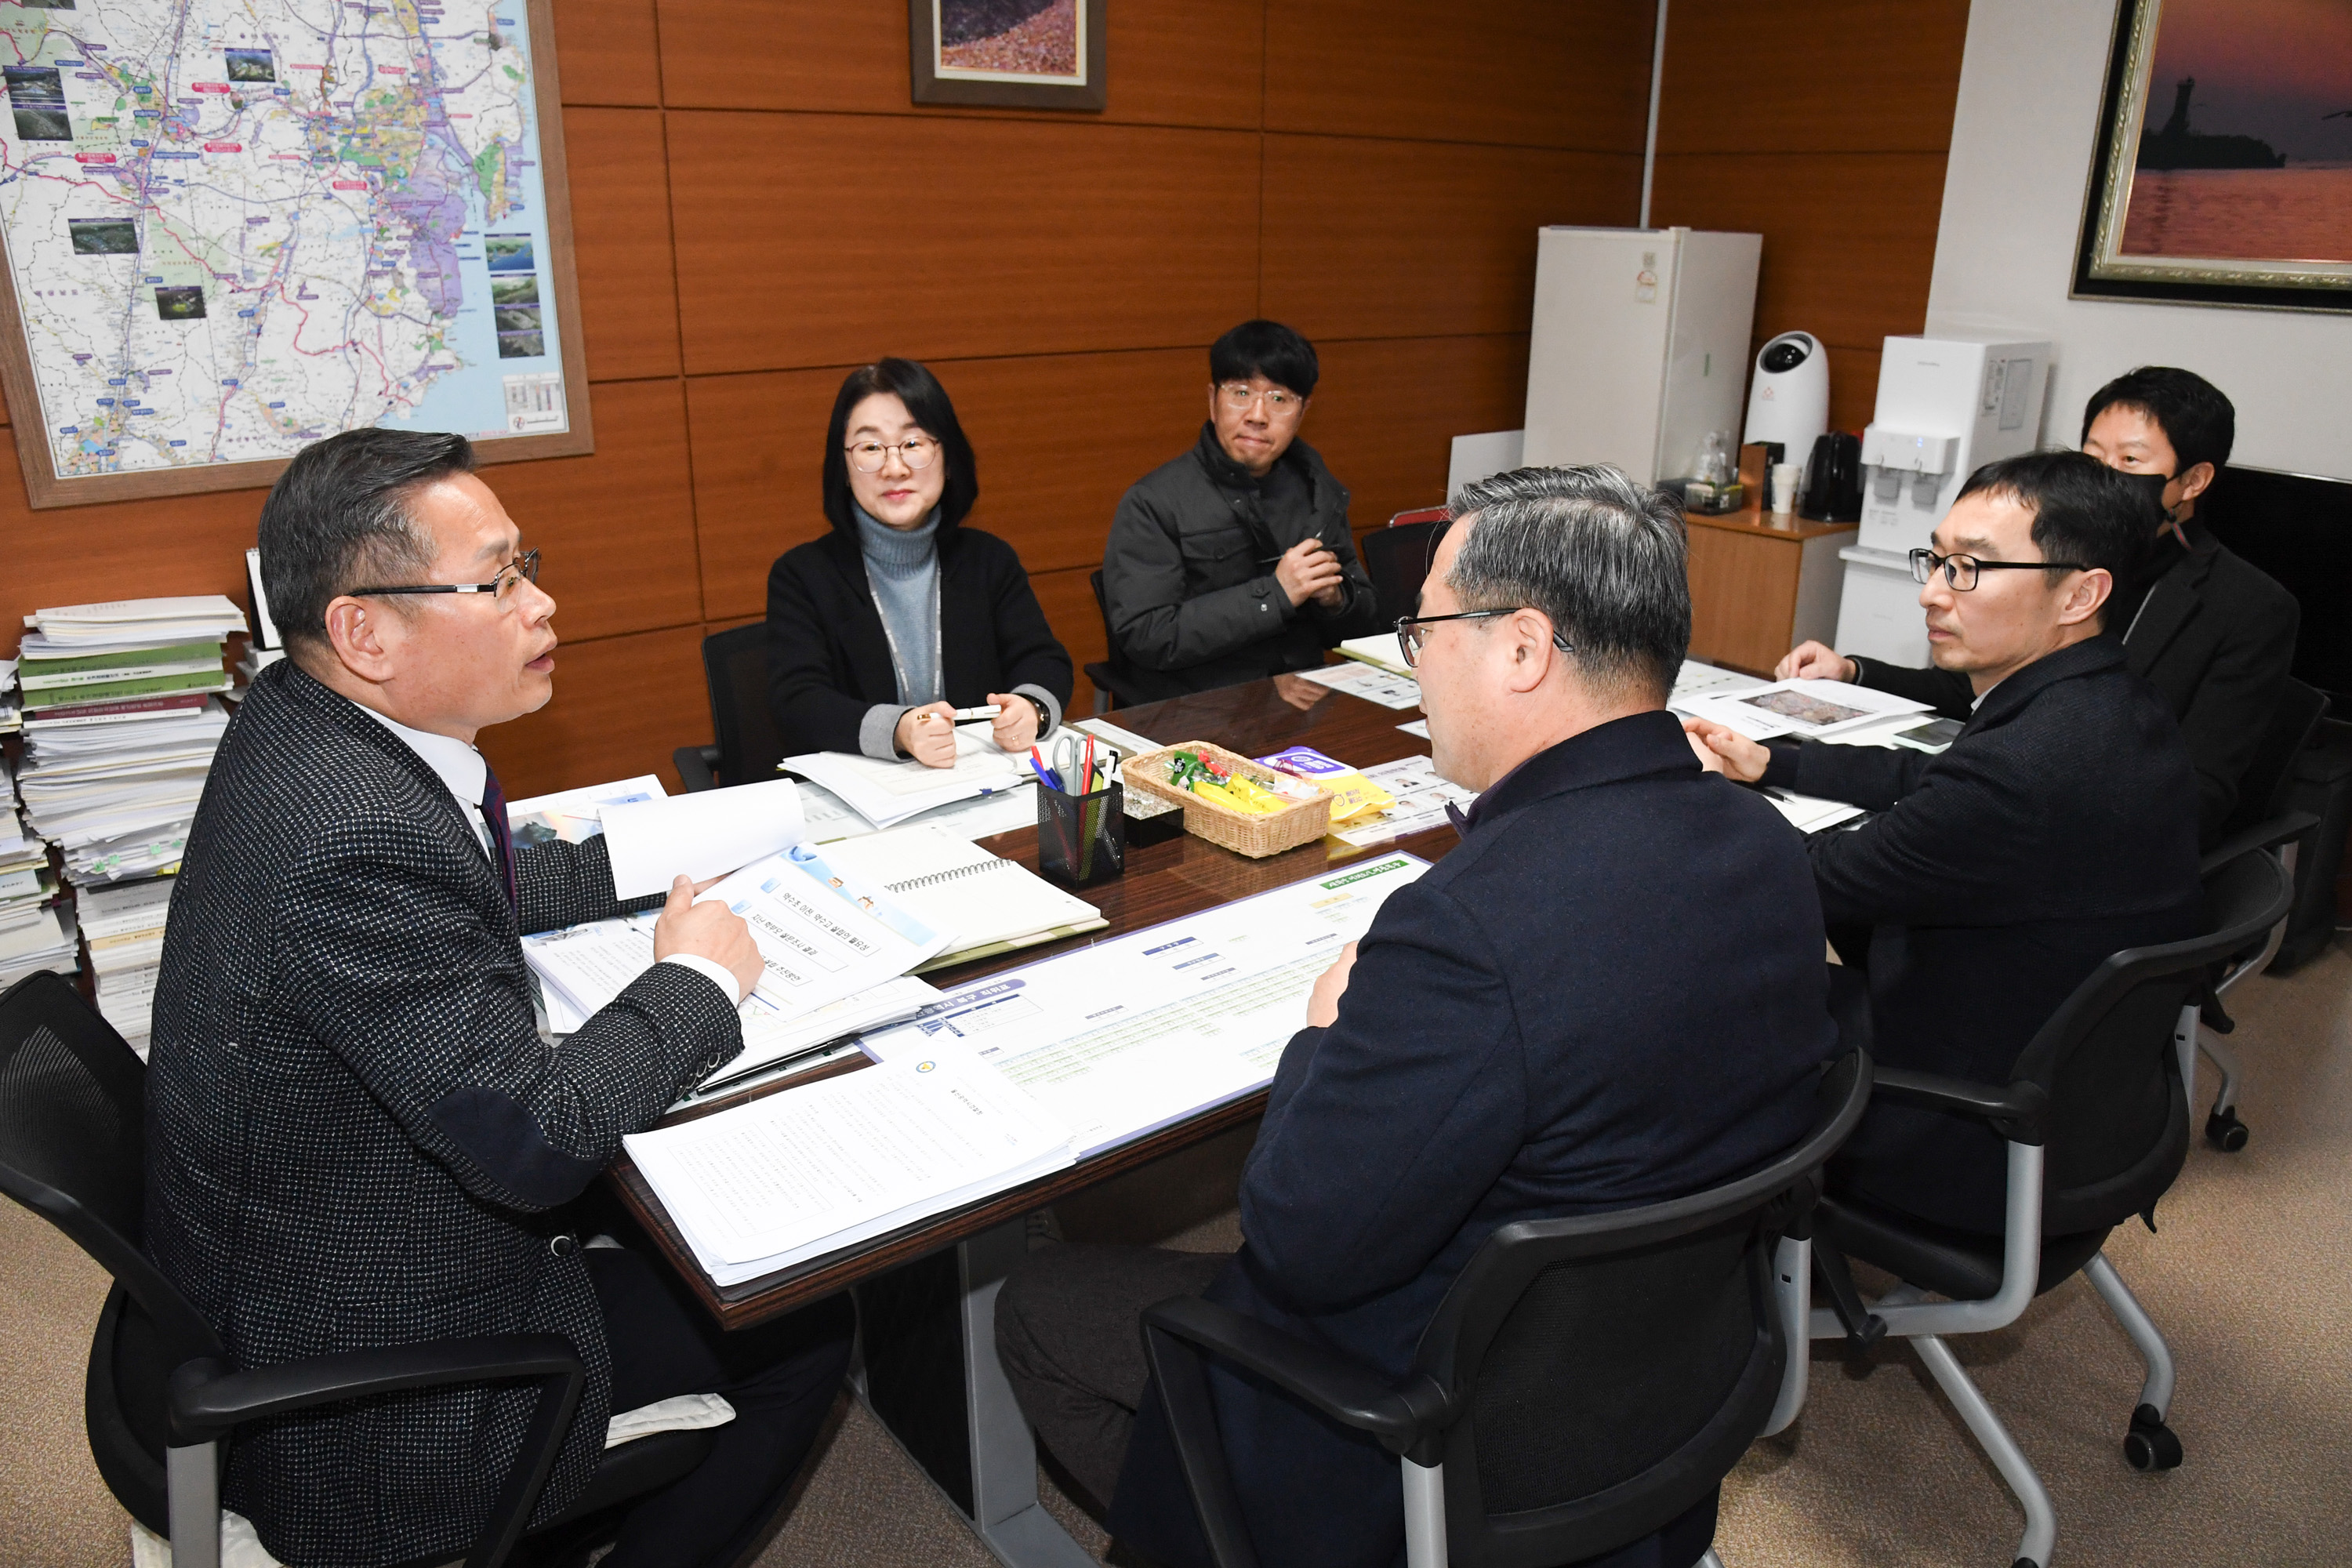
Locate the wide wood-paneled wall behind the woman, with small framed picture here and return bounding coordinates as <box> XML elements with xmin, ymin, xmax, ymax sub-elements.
<box><xmin>0</xmin><ymin>0</ymin><xmax>1656</xmax><ymax>797</ymax></box>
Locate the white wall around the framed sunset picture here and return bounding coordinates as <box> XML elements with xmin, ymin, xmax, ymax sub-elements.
<box><xmin>1926</xmin><ymin>0</ymin><xmax>2352</xmax><ymax>480</ymax></box>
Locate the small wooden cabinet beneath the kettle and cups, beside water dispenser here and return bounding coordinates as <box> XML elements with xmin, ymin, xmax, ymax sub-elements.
<box><xmin>1686</xmin><ymin>510</ymin><xmax>1856</xmax><ymax>675</ymax></box>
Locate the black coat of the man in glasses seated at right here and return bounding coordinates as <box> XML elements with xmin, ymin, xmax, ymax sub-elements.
<box><xmin>1764</xmin><ymin>637</ymin><xmax>2204</xmax><ymax>1232</ymax></box>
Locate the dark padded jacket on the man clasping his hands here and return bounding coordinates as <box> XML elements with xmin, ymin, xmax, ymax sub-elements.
<box><xmin>1103</xmin><ymin>426</ymin><xmax>1381</xmax><ymax>701</ymax></box>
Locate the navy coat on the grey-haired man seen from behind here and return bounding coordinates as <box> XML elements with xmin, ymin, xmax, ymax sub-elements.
<box><xmin>1110</xmin><ymin>713</ymin><xmax>1837</xmax><ymax>1568</ymax></box>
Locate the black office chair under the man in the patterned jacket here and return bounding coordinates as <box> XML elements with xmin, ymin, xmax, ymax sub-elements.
<box><xmin>0</xmin><ymin>973</ymin><xmax>715</xmax><ymax>1568</ymax></box>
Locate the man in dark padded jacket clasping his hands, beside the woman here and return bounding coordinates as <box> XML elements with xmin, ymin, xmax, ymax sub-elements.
<box><xmin>1103</xmin><ymin>322</ymin><xmax>1381</xmax><ymax>701</ymax></box>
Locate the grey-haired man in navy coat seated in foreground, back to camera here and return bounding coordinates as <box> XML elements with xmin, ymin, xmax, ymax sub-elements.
<box><xmin>997</xmin><ymin>468</ymin><xmax>1837</xmax><ymax>1568</ymax></box>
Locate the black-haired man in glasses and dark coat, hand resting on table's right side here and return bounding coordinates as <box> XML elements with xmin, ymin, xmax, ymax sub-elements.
<box><xmin>1684</xmin><ymin>452</ymin><xmax>2204</xmax><ymax>1234</ymax></box>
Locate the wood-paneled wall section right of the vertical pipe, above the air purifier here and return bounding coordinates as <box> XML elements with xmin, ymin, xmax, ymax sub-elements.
<box><xmin>1651</xmin><ymin>0</ymin><xmax>1969</xmax><ymax>430</ymax></box>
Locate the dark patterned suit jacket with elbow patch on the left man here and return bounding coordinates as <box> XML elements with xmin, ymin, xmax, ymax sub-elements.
<box><xmin>146</xmin><ymin>661</ymin><xmax>743</xmax><ymax>1568</ymax></box>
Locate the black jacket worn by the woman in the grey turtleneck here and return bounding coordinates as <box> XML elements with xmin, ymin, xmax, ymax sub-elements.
<box><xmin>767</xmin><ymin>522</ymin><xmax>1070</xmax><ymax>757</ymax></box>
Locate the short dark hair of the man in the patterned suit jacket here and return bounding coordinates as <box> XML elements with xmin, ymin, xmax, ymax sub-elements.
<box><xmin>259</xmin><ymin>426</ymin><xmax>475</xmax><ymax>642</ymax></box>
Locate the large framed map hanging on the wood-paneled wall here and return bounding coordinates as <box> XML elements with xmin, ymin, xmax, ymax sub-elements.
<box><xmin>0</xmin><ymin>0</ymin><xmax>595</xmax><ymax>506</ymax></box>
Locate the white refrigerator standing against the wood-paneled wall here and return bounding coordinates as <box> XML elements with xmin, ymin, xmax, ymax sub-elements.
<box><xmin>1522</xmin><ymin>226</ymin><xmax>1759</xmax><ymax>485</ymax></box>
